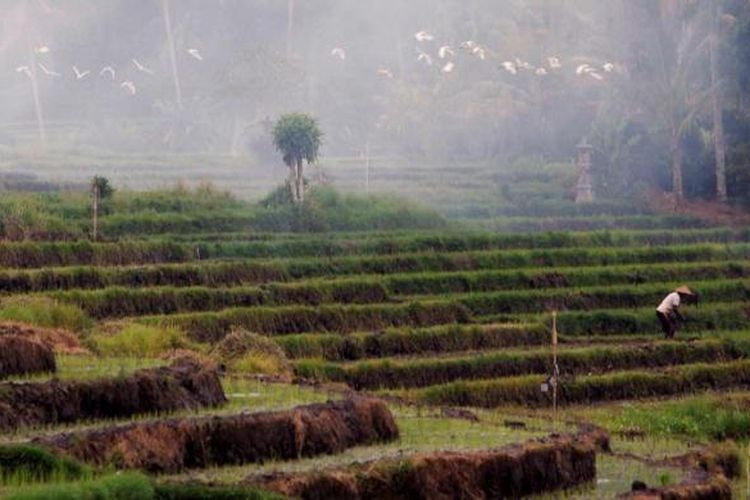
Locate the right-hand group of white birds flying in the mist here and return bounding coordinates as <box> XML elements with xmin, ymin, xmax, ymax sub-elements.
<box><xmin>331</xmin><ymin>31</ymin><xmax>615</xmax><ymax>81</ymax></box>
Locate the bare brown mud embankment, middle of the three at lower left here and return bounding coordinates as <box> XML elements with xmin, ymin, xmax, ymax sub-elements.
<box><xmin>35</xmin><ymin>397</ymin><xmax>399</xmax><ymax>472</ymax></box>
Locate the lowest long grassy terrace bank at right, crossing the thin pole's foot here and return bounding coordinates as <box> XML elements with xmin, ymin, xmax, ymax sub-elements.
<box><xmin>412</xmin><ymin>360</ymin><xmax>750</xmax><ymax>408</ymax></box>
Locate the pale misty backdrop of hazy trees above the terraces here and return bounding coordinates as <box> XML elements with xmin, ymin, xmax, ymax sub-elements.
<box><xmin>0</xmin><ymin>0</ymin><xmax>750</xmax><ymax>204</ymax></box>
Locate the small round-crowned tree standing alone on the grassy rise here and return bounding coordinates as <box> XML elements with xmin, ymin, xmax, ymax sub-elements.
<box><xmin>273</xmin><ymin>113</ymin><xmax>323</xmax><ymax>204</ymax></box>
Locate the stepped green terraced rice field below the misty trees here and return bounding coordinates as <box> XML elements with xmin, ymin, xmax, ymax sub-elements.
<box><xmin>0</xmin><ymin>228</ymin><xmax>750</xmax><ymax>498</ymax></box>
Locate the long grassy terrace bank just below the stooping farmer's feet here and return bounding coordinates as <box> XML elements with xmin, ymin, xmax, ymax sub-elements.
<box><xmin>302</xmin><ymin>340</ymin><xmax>750</xmax><ymax>390</ymax></box>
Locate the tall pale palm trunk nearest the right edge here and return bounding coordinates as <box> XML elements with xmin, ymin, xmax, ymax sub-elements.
<box><xmin>709</xmin><ymin>0</ymin><xmax>727</xmax><ymax>203</ymax></box>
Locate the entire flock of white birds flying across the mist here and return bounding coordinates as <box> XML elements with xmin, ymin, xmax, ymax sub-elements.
<box><xmin>16</xmin><ymin>31</ymin><xmax>615</xmax><ymax>99</ymax></box>
